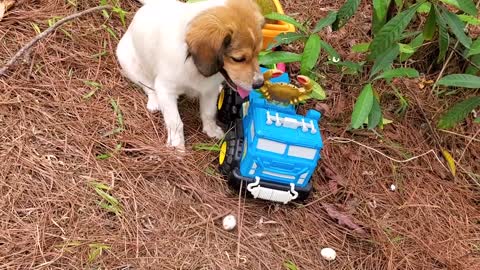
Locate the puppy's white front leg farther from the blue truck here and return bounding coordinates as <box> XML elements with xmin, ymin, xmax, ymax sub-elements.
<box><xmin>155</xmin><ymin>81</ymin><xmax>185</xmax><ymax>150</ymax></box>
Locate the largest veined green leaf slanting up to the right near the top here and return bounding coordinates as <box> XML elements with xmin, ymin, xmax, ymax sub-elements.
<box><xmin>368</xmin><ymin>4</ymin><xmax>419</xmax><ymax>60</ymax></box>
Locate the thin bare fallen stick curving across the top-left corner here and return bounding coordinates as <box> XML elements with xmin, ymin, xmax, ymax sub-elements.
<box><xmin>0</xmin><ymin>5</ymin><xmax>112</xmax><ymax>77</ymax></box>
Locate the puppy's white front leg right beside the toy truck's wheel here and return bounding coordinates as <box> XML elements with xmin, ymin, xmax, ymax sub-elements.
<box><xmin>200</xmin><ymin>91</ymin><xmax>225</xmax><ymax>139</ymax></box>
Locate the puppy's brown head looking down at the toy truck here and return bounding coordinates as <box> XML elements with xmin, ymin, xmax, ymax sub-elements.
<box><xmin>186</xmin><ymin>0</ymin><xmax>265</xmax><ymax>97</ymax></box>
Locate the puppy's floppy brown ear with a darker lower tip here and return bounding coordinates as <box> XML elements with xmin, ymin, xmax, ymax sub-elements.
<box><xmin>186</xmin><ymin>10</ymin><xmax>233</xmax><ymax>77</ymax></box>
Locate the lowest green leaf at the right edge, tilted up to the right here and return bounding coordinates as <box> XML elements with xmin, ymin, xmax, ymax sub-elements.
<box><xmin>437</xmin><ymin>96</ymin><xmax>480</xmax><ymax>129</ymax></box>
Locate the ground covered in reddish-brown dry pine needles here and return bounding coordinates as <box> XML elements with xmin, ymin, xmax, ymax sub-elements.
<box><xmin>0</xmin><ymin>0</ymin><xmax>480</xmax><ymax>269</ymax></box>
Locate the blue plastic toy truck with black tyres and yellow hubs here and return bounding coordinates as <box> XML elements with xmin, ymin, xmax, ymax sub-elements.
<box><xmin>217</xmin><ymin>68</ymin><xmax>323</xmax><ymax>204</ymax></box>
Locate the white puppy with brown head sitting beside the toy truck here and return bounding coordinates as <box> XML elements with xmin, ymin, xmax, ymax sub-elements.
<box><xmin>116</xmin><ymin>0</ymin><xmax>264</xmax><ymax>149</ymax></box>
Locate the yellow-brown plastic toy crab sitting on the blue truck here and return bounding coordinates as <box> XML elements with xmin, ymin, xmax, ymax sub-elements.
<box><xmin>258</xmin><ymin>69</ymin><xmax>313</xmax><ymax>105</ymax></box>
